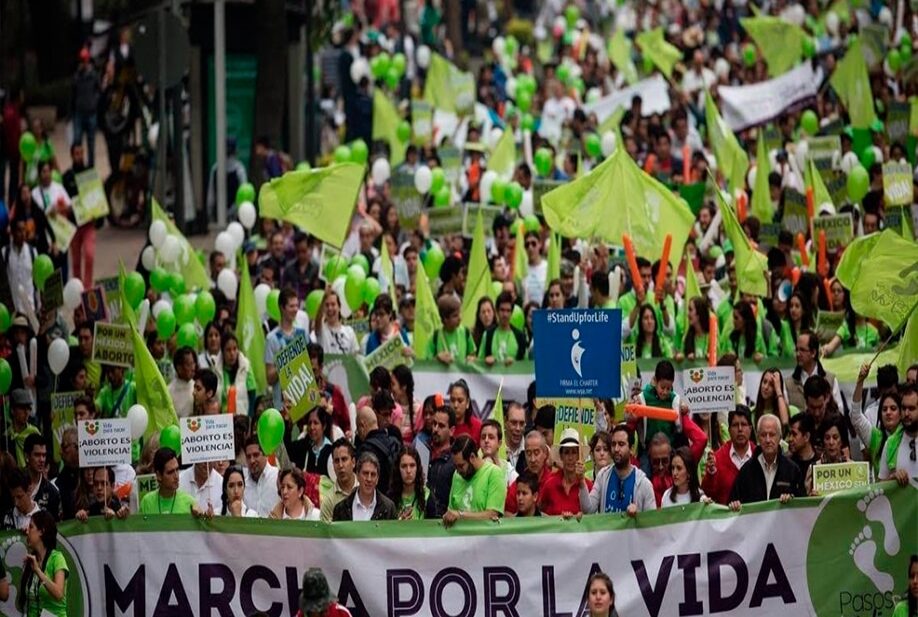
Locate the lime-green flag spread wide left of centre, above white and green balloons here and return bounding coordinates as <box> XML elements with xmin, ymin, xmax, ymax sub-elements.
<box><xmin>258</xmin><ymin>163</ymin><xmax>364</xmax><ymax>248</ymax></box>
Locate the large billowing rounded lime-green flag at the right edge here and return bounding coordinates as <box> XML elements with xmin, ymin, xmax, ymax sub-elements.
<box><xmin>835</xmin><ymin>229</ymin><xmax>918</xmax><ymax>331</ymax></box>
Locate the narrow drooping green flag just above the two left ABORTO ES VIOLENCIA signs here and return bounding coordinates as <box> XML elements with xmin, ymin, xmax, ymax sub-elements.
<box><xmin>118</xmin><ymin>262</ymin><xmax>176</xmax><ymax>438</ymax></box>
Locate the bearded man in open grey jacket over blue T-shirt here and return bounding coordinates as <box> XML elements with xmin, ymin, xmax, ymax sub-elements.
<box><xmin>580</xmin><ymin>424</ymin><xmax>657</xmax><ymax>516</ymax></box>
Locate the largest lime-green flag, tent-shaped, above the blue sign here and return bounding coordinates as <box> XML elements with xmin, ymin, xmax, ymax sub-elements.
<box><xmin>542</xmin><ymin>148</ymin><xmax>695</xmax><ymax>263</ymax></box>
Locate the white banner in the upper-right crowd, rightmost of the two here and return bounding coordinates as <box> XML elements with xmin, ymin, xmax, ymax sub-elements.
<box><xmin>717</xmin><ymin>62</ymin><xmax>823</xmax><ymax>131</ymax></box>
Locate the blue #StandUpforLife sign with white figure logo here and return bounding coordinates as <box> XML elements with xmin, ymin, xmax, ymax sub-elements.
<box><xmin>532</xmin><ymin>309</ymin><xmax>622</xmax><ymax>398</ymax></box>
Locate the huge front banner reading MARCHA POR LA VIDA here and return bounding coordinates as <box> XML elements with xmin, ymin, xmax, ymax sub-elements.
<box><xmin>0</xmin><ymin>483</ymin><xmax>918</xmax><ymax>617</ymax></box>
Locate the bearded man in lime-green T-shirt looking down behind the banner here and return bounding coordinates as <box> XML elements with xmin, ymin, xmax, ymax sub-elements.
<box><xmin>443</xmin><ymin>435</ymin><xmax>507</xmax><ymax>527</ymax></box>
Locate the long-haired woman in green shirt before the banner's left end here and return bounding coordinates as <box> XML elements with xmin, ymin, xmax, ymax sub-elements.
<box><xmin>17</xmin><ymin>510</ymin><xmax>70</xmax><ymax>617</ymax></box>
